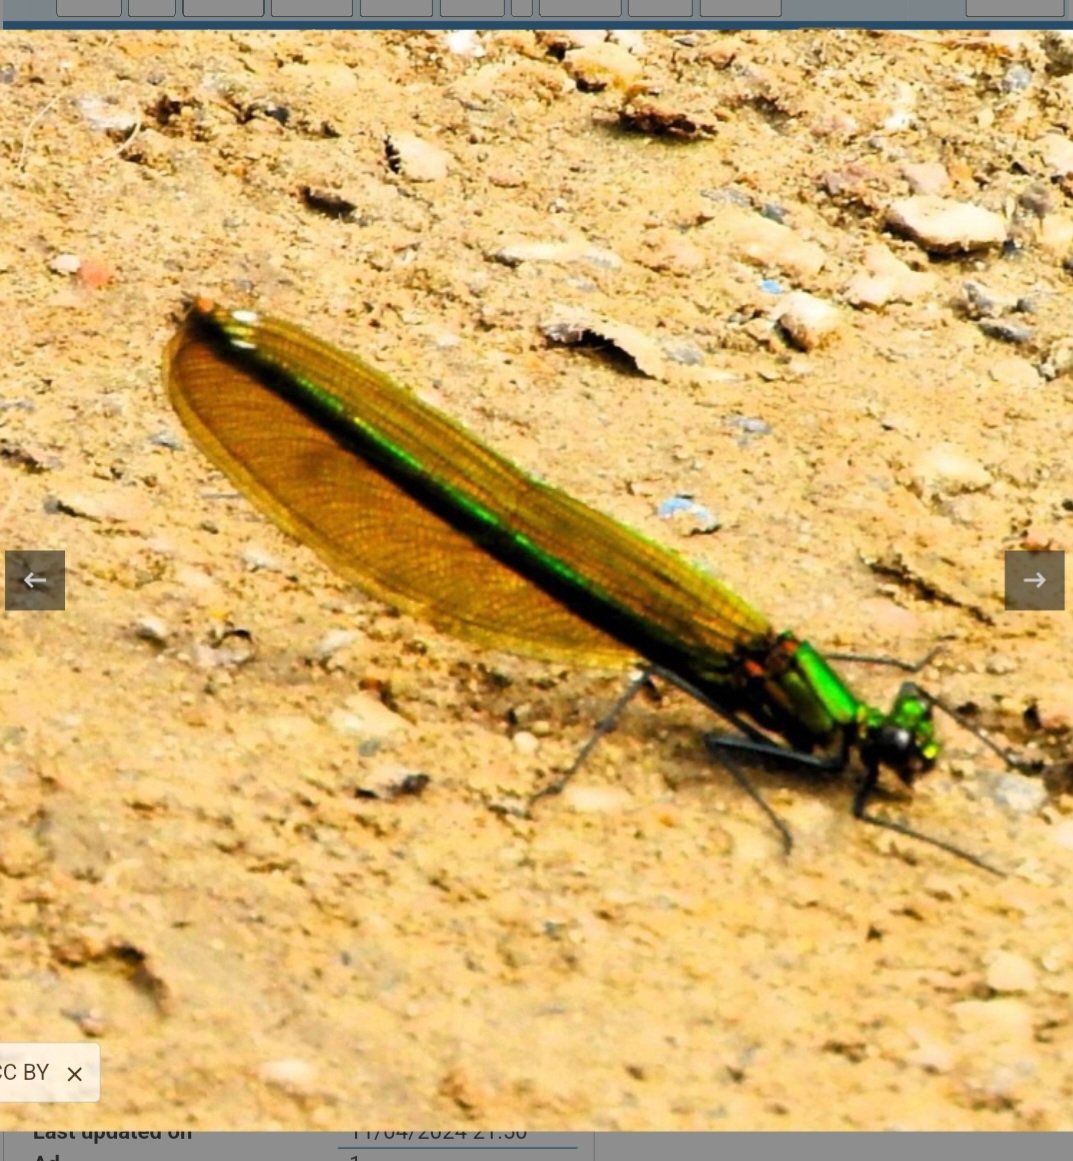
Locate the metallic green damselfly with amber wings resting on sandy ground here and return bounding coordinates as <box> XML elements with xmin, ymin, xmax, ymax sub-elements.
<box><xmin>165</xmin><ymin>298</ymin><xmax>991</xmax><ymax>870</ymax></box>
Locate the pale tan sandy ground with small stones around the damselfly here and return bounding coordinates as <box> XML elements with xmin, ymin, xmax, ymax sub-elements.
<box><xmin>0</xmin><ymin>24</ymin><xmax>1073</xmax><ymax>1130</ymax></box>
